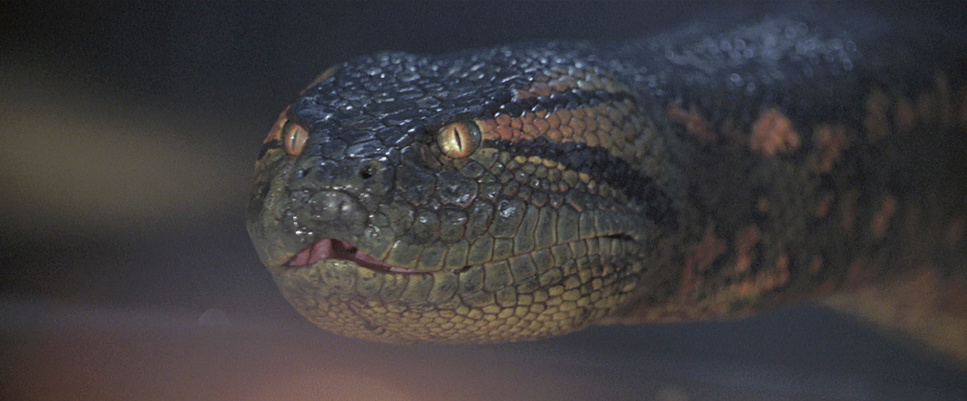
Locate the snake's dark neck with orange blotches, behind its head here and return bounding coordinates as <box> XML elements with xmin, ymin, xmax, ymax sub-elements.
<box><xmin>601</xmin><ymin>20</ymin><xmax>967</xmax><ymax>322</ymax></box>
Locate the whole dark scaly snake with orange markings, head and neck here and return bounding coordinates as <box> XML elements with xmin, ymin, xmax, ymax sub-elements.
<box><xmin>246</xmin><ymin>16</ymin><xmax>967</xmax><ymax>354</ymax></box>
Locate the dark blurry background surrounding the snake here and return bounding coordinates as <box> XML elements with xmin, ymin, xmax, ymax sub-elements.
<box><xmin>0</xmin><ymin>2</ymin><xmax>967</xmax><ymax>401</ymax></box>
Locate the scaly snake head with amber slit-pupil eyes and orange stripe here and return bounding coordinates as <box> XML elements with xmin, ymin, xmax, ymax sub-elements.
<box><xmin>247</xmin><ymin>44</ymin><xmax>674</xmax><ymax>343</ymax></box>
